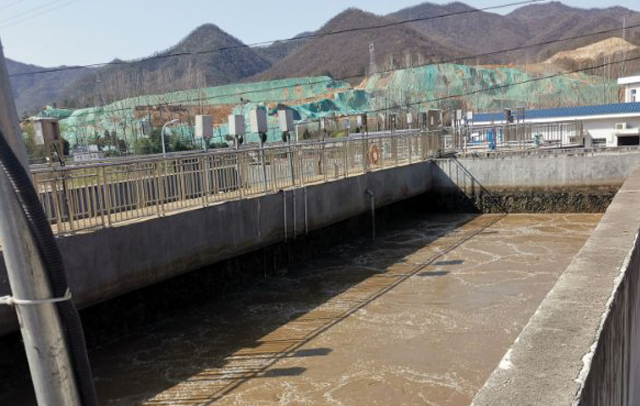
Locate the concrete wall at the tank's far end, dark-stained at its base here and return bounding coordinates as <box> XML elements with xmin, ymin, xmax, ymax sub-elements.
<box><xmin>433</xmin><ymin>149</ymin><xmax>640</xmax><ymax>213</ymax></box>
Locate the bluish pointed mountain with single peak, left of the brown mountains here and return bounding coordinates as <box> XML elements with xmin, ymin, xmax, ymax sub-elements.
<box><xmin>57</xmin><ymin>24</ymin><xmax>271</xmax><ymax>105</ymax></box>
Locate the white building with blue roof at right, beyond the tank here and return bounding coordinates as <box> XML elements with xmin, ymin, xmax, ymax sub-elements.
<box><xmin>471</xmin><ymin>103</ymin><xmax>640</xmax><ymax>147</ymax></box>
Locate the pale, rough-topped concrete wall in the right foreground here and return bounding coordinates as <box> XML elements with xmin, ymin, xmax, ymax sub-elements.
<box><xmin>473</xmin><ymin>160</ymin><xmax>640</xmax><ymax>406</ymax></box>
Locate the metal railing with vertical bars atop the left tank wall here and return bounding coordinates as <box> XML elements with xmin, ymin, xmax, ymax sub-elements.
<box><xmin>32</xmin><ymin>131</ymin><xmax>442</xmax><ymax>234</ymax></box>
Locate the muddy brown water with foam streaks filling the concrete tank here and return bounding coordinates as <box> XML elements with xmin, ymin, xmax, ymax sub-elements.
<box><xmin>0</xmin><ymin>214</ymin><xmax>601</xmax><ymax>406</ymax></box>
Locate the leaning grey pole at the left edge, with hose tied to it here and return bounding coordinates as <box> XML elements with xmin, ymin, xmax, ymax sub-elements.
<box><xmin>0</xmin><ymin>35</ymin><xmax>80</xmax><ymax>406</ymax></box>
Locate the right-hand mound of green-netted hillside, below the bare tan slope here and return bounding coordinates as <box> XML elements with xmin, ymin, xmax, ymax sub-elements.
<box><xmin>364</xmin><ymin>64</ymin><xmax>617</xmax><ymax>111</ymax></box>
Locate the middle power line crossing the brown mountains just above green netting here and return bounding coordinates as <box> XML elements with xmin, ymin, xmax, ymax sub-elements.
<box><xmin>61</xmin><ymin>24</ymin><xmax>640</xmax><ymax>118</ymax></box>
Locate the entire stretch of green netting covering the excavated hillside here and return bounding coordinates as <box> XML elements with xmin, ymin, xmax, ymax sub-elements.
<box><xmin>57</xmin><ymin>64</ymin><xmax>617</xmax><ymax>150</ymax></box>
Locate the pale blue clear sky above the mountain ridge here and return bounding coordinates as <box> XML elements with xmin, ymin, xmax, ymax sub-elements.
<box><xmin>0</xmin><ymin>0</ymin><xmax>640</xmax><ymax>67</ymax></box>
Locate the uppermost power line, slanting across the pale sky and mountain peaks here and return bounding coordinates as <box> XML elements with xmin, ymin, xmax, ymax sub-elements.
<box><xmin>9</xmin><ymin>0</ymin><xmax>546</xmax><ymax>77</ymax></box>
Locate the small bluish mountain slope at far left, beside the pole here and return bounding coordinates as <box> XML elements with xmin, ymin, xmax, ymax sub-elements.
<box><xmin>6</xmin><ymin>59</ymin><xmax>88</xmax><ymax>115</ymax></box>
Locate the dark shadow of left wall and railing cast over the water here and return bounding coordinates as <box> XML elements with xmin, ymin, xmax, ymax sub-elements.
<box><xmin>0</xmin><ymin>192</ymin><xmax>502</xmax><ymax>406</ymax></box>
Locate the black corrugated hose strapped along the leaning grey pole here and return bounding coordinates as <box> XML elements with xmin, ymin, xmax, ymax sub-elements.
<box><xmin>0</xmin><ymin>131</ymin><xmax>98</xmax><ymax>406</ymax></box>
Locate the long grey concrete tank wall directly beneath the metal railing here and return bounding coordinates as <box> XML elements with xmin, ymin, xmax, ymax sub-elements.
<box><xmin>0</xmin><ymin>163</ymin><xmax>431</xmax><ymax>334</ymax></box>
